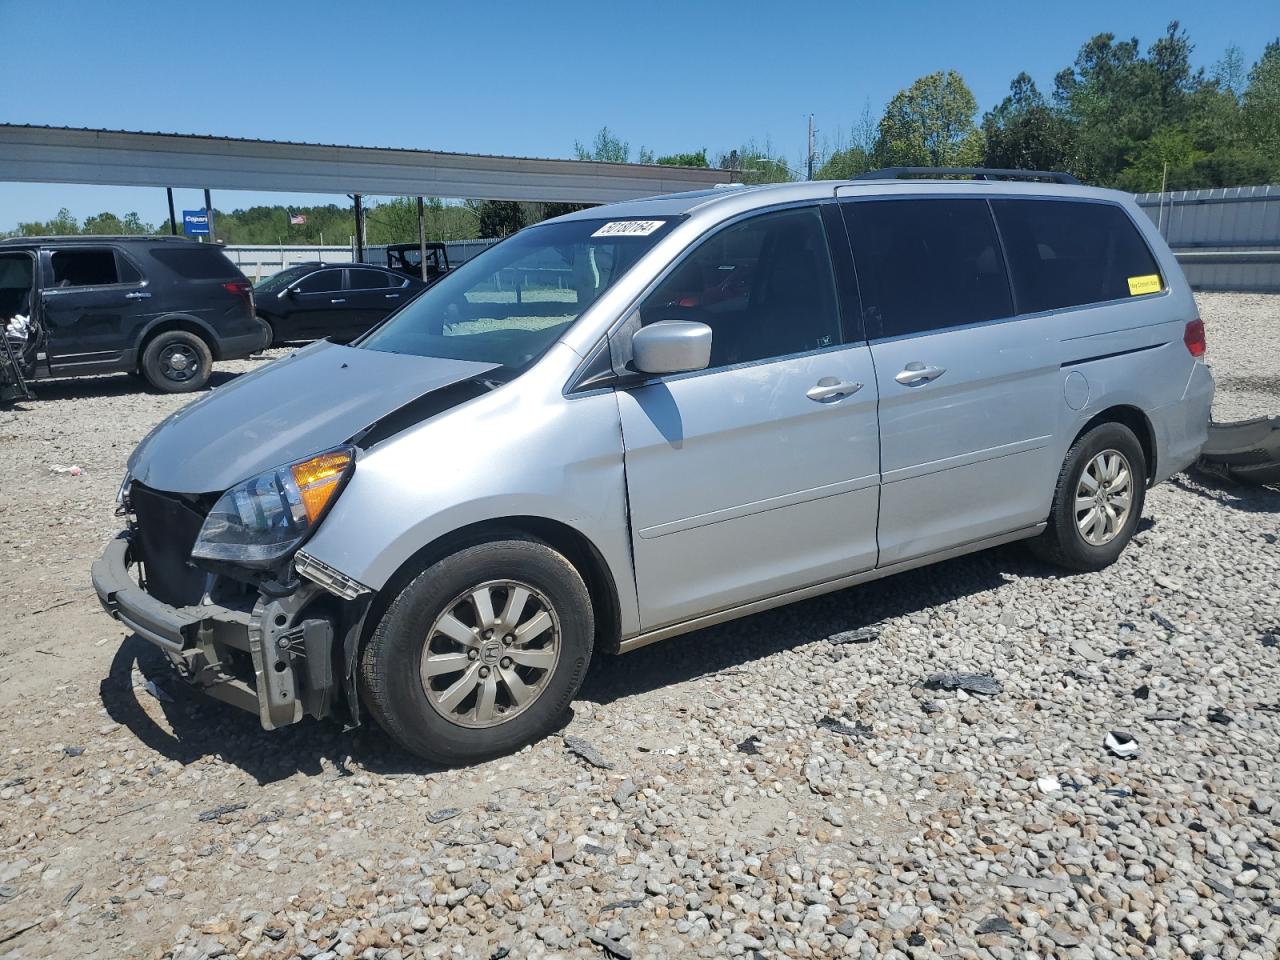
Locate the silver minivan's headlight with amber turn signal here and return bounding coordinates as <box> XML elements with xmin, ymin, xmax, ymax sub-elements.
<box><xmin>191</xmin><ymin>447</ymin><xmax>356</xmax><ymax>567</ymax></box>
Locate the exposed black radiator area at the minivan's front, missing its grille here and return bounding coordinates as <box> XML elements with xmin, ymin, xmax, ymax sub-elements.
<box><xmin>129</xmin><ymin>481</ymin><xmax>205</xmax><ymax>607</ymax></box>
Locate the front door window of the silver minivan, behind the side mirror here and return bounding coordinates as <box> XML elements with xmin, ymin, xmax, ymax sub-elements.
<box><xmin>640</xmin><ymin>207</ymin><xmax>840</xmax><ymax>367</ymax></box>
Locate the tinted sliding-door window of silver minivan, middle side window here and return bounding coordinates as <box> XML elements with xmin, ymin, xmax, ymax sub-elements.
<box><xmin>844</xmin><ymin>200</ymin><xmax>1014</xmax><ymax>337</ymax></box>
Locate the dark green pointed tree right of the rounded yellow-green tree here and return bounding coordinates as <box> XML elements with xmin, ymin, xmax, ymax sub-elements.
<box><xmin>982</xmin><ymin>73</ymin><xmax>1073</xmax><ymax>170</ymax></box>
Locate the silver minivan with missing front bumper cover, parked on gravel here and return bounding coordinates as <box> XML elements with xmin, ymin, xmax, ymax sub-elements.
<box><xmin>93</xmin><ymin>172</ymin><xmax>1213</xmax><ymax>764</ymax></box>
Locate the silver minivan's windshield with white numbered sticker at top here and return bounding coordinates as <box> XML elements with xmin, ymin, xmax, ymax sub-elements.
<box><xmin>358</xmin><ymin>219</ymin><xmax>675</xmax><ymax>374</ymax></box>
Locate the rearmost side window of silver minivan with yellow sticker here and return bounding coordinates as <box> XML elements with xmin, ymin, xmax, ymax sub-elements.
<box><xmin>992</xmin><ymin>200</ymin><xmax>1164</xmax><ymax>314</ymax></box>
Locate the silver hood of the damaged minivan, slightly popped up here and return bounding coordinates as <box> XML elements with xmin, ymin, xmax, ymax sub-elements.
<box><xmin>129</xmin><ymin>342</ymin><xmax>498</xmax><ymax>493</ymax></box>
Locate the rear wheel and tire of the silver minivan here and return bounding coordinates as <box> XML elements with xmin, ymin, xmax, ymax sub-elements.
<box><xmin>1030</xmin><ymin>422</ymin><xmax>1147</xmax><ymax>571</ymax></box>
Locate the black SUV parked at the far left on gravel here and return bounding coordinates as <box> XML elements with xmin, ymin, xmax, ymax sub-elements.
<box><xmin>0</xmin><ymin>237</ymin><xmax>269</xmax><ymax>393</ymax></box>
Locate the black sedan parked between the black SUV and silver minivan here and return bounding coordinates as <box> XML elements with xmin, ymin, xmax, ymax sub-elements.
<box><xmin>253</xmin><ymin>264</ymin><xmax>426</xmax><ymax>343</ymax></box>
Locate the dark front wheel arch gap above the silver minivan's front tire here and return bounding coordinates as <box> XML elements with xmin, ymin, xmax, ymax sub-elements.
<box><xmin>361</xmin><ymin>516</ymin><xmax>622</xmax><ymax>653</ymax></box>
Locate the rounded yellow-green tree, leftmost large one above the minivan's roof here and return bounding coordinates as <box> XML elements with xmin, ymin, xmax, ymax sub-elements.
<box><xmin>876</xmin><ymin>70</ymin><xmax>983</xmax><ymax>166</ymax></box>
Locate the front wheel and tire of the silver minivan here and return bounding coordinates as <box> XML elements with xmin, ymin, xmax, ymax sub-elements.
<box><xmin>360</xmin><ymin>539</ymin><xmax>595</xmax><ymax>765</ymax></box>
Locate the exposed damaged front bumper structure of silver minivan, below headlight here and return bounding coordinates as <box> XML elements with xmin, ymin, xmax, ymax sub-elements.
<box><xmin>92</xmin><ymin>531</ymin><xmax>369</xmax><ymax>730</ymax></box>
